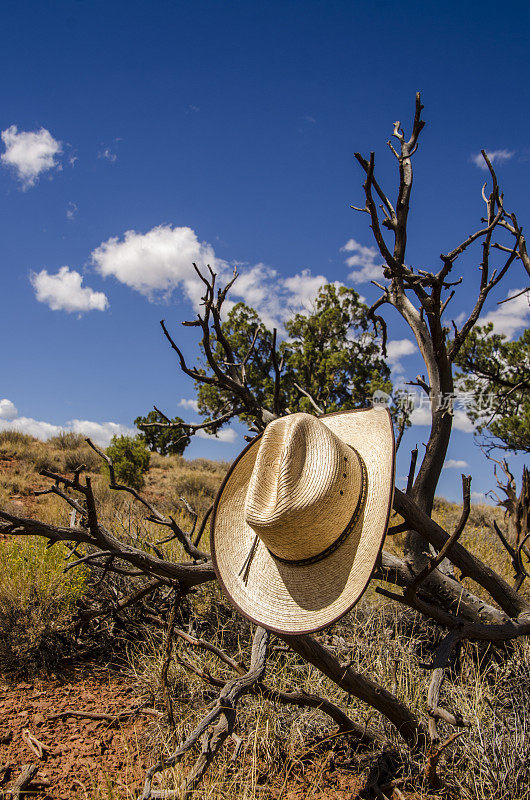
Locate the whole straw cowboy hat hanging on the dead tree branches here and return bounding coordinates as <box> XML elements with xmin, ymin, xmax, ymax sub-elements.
<box><xmin>211</xmin><ymin>408</ymin><xmax>394</xmax><ymax>634</ymax></box>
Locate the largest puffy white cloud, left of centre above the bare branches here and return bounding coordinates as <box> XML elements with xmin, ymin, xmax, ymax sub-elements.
<box><xmin>92</xmin><ymin>225</ymin><xmax>224</xmax><ymax>304</ymax></box>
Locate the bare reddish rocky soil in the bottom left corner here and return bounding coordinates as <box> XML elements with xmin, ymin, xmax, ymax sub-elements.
<box><xmin>0</xmin><ymin>665</ymin><xmax>152</xmax><ymax>800</ymax></box>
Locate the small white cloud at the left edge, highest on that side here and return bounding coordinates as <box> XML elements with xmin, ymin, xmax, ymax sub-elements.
<box><xmin>2</xmin><ymin>125</ymin><xmax>62</xmax><ymax>189</ymax></box>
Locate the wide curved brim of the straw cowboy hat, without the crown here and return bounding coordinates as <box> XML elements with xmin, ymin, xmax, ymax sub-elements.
<box><xmin>210</xmin><ymin>408</ymin><xmax>395</xmax><ymax>634</ymax></box>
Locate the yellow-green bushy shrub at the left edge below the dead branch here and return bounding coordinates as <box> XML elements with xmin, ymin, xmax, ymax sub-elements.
<box><xmin>0</xmin><ymin>537</ymin><xmax>87</xmax><ymax>671</ymax></box>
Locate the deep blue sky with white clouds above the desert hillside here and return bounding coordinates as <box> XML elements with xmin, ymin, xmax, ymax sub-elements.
<box><xmin>0</xmin><ymin>0</ymin><xmax>530</xmax><ymax>498</ymax></box>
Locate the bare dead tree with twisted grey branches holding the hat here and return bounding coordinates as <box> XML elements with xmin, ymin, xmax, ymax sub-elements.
<box><xmin>0</xmin><ymin>95</ymin><xmax>530</xmax><ymax>800</ymax></box>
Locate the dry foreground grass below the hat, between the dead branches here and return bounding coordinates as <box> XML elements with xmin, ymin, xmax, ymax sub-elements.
<box><xmin>125</xmin><ymin>587</ymin><xmax>530</xmax><ymax>800</ymax></box>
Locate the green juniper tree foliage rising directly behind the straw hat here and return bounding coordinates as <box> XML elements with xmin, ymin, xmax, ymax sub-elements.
<box><xmin>197</xmin><ymin>284</ymin><xmax>392</xmax><ymax>428</ymax></box>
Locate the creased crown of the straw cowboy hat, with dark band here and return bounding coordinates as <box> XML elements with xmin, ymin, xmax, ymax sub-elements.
<box><xmin>245</xmin><ymin>413</ymin><xmax>363</xmax><ymax>561</ymax></box>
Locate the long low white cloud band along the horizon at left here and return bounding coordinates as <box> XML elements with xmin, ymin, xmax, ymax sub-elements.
<box><xmin>0</xmin><ymin>399</ymin><xmax>137</xmax><ymax>447</ymax></box>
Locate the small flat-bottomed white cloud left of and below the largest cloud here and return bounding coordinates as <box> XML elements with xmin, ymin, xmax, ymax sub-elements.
<box><xmin>30</xmin><ymin>267</ymin><xmax>108</xmax><ymax>313</ymax></box>
